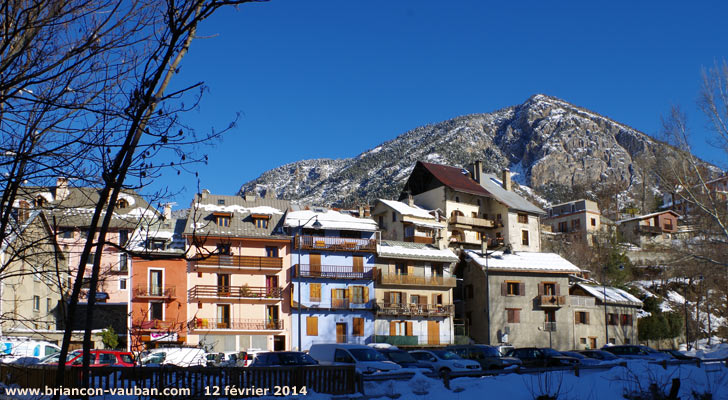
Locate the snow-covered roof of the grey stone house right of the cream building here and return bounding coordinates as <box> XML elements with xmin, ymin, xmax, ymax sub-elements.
<box><xmin>465</xmin><ymin>250</ymin><xmax>581</xmax><ymax>273</ymax></box>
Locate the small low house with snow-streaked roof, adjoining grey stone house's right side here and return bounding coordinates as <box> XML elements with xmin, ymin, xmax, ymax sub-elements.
<box><xmin>569</xmin><ymin>283</ymin><xmax>642</xmax><ymax>349</ymax></box>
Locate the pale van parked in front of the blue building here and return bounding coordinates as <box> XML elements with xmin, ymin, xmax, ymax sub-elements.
<box><xmin>308</xmin><ymin>343</ymin><xmax>402</xmax><ymax>374</ymax></box>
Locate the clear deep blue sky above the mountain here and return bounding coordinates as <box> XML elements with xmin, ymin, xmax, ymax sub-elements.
<box><xmin>152</xmin><ymin>0</ymin><xmax>728</xmax><ymax>207</ymax></box>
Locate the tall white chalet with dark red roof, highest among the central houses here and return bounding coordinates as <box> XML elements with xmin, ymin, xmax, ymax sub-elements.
<box><xmin>400</xmin><ymin>161</ymin><xmax>544</xmax><ymax>251</ymax></box>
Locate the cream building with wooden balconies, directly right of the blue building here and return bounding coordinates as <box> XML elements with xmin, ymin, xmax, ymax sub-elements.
<box><xmin>374</xmin><ymin>240</ymin><xmax>458</xmax><ymax>346</ymax></box>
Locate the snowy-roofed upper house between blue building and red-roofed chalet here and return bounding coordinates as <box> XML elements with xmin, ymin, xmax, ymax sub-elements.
<box><xmin>371</xmin><ymin>196</ymin><xmax>447</xmax><ymax>246</ymax></box>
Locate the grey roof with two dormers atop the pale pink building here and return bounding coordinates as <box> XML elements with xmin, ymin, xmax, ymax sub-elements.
<box><xmin>184</xmin><ymin>193</ymin><xmax>290</xmax><ymax>238</ymax></box>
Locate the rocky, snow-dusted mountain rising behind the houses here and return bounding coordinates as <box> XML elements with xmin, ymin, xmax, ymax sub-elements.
<box><xmin>240</xmin><ymin>95</ymin><xmax>674</xmax><ymax>206</ymax></box>
